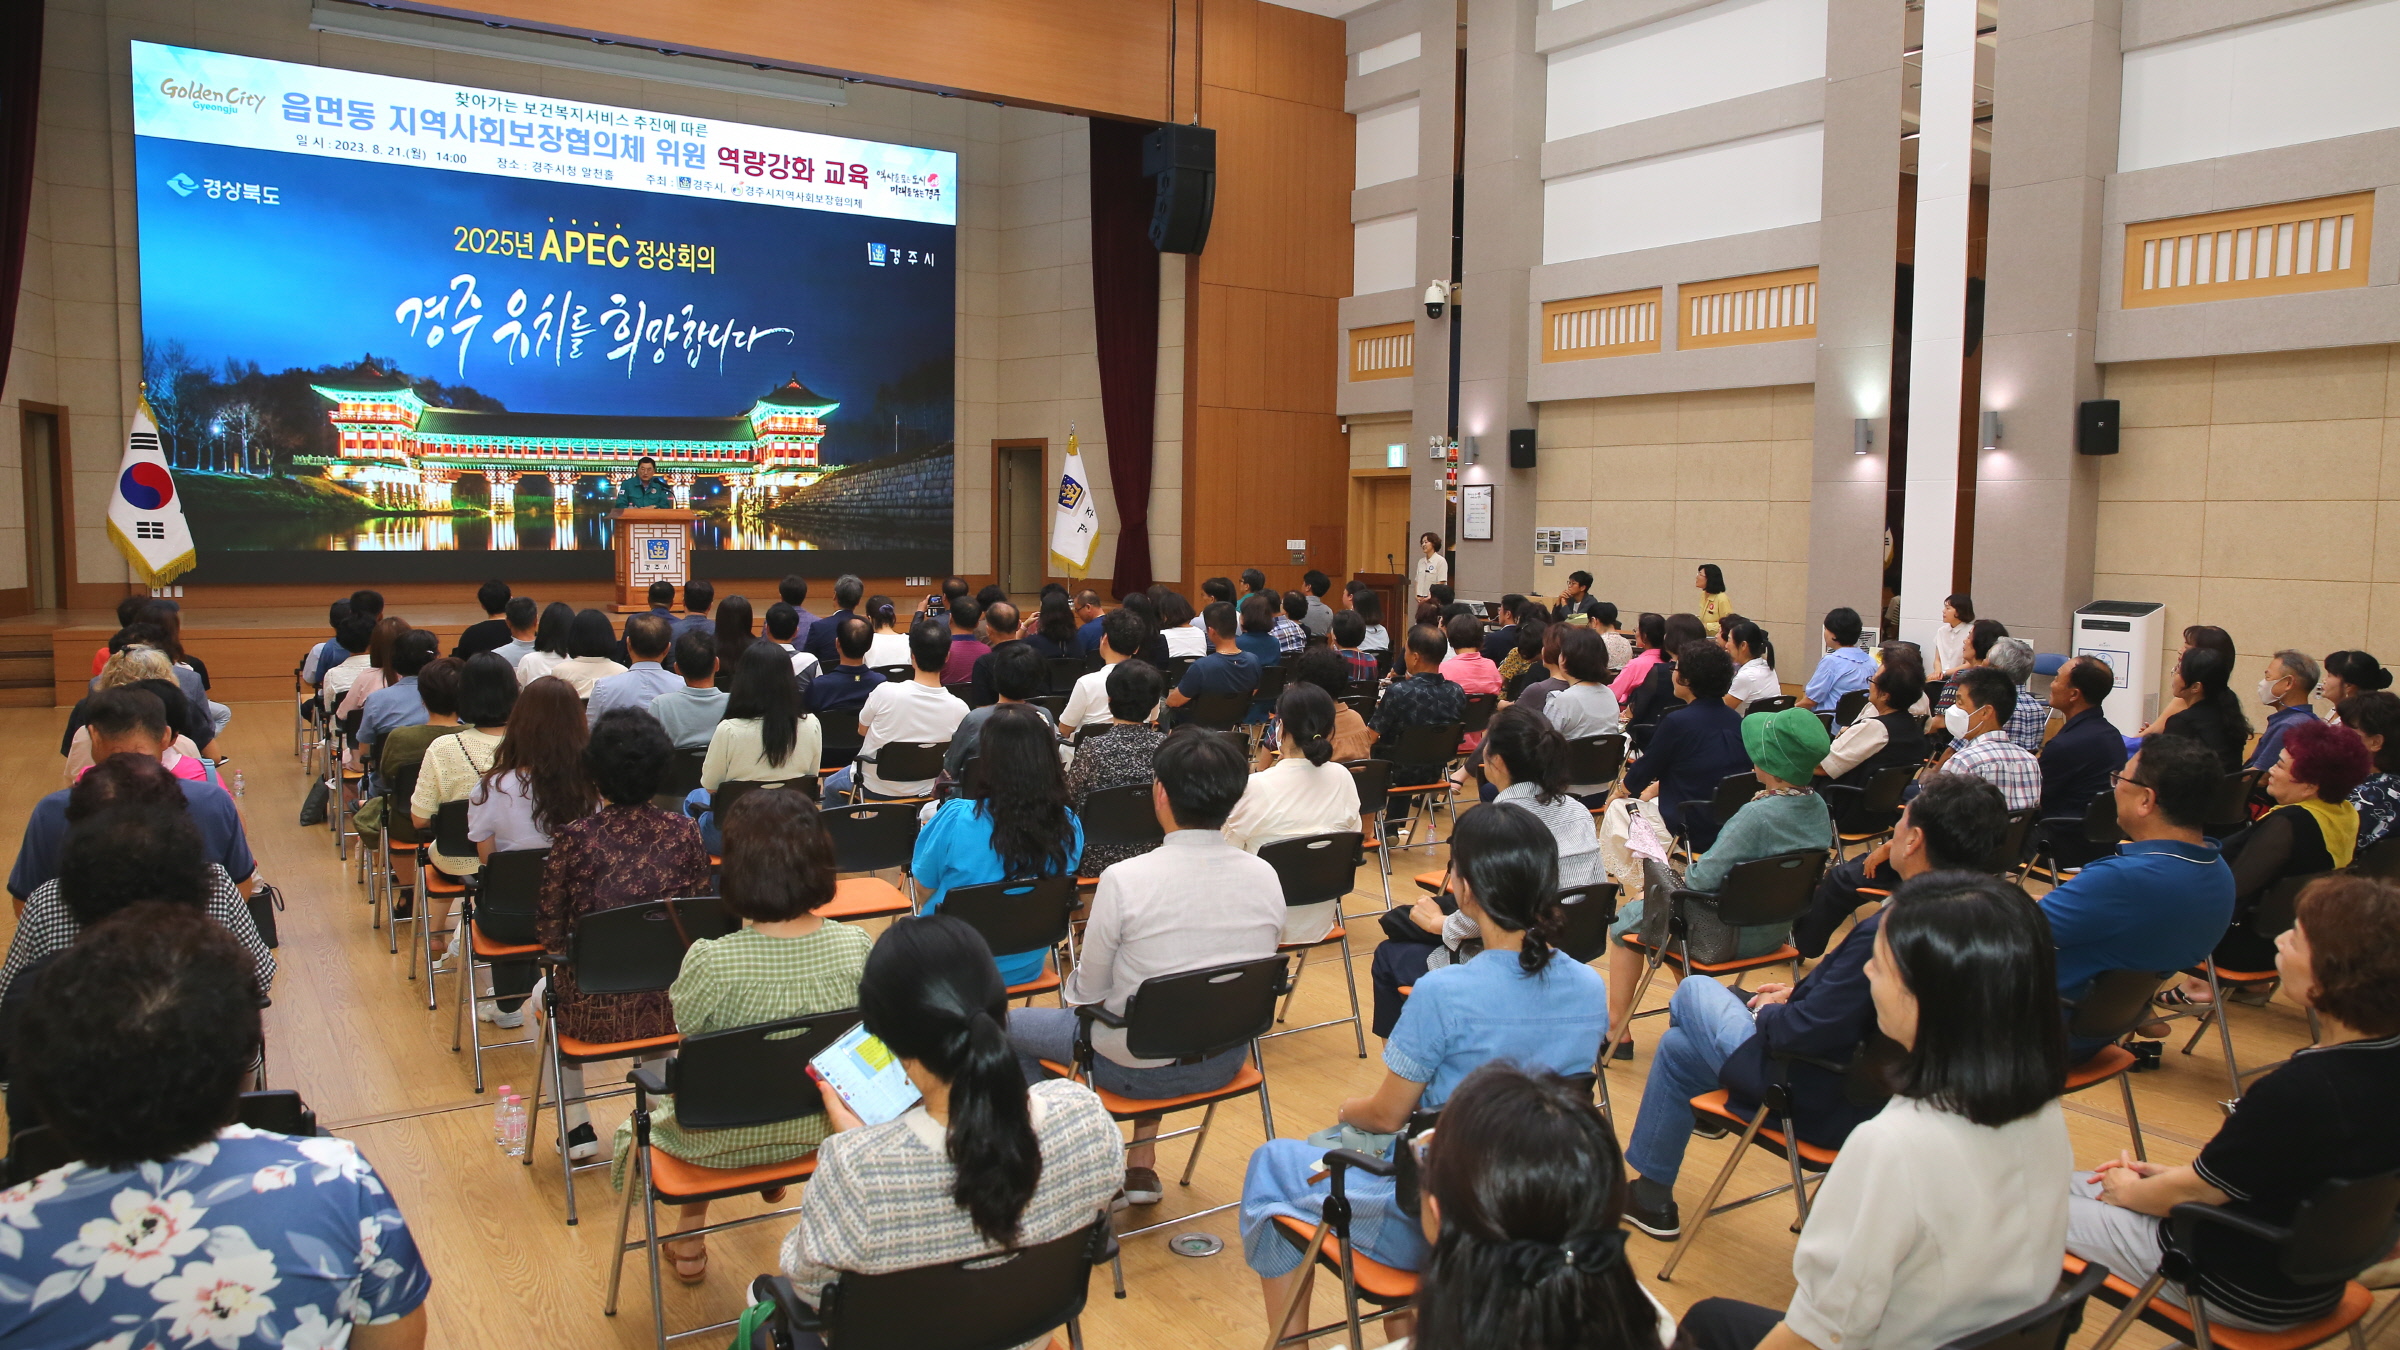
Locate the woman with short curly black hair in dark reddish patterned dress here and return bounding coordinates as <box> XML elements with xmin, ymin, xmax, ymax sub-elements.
<box><xmin>535</xmin><ymin>709</ymin><xmax>710</xmax><ymax>1160</ymax></box>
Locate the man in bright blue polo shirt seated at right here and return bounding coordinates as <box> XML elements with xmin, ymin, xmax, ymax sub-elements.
<box><xmin>2038</xmin><ymin>735</ymin><xmax>2234</xmax><ymax>1064</ymax></box>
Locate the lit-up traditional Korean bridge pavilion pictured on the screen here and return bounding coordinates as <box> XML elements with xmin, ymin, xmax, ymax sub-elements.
<box><xmin>298</xmin><ymin>365</ymin><xmax>840</xmax><ymax>514</ymax></box>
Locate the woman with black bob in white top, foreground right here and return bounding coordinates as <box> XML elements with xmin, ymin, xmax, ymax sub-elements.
<box><xmin>1682</xmin><ymin>872</ymin><xmax>2074</xmax><ymax>1350</ymax></box>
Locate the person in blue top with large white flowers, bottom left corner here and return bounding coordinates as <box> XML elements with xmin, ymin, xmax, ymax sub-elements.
<box><xmin>0</xmin><ymin>903</ymin><xmax>432</xmax><ymax>1350</ymax></box>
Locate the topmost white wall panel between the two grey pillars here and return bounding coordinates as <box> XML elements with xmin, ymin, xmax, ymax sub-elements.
<box><xmin>1543</xmin><ymin>0</ymin><xmax>1826</xmax><ymax>142</ymax></box>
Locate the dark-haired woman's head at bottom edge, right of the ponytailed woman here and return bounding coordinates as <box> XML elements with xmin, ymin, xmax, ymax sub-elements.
<box><xmin>1392</xmin><ymin>1059</ymin><xmax>1675</xmax><ymax>1350</ymax></box>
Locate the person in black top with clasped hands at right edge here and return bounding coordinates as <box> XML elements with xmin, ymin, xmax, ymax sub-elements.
<box><xmin>2066</xmin><ymin>877</ymin><xmax>2400</xmax><ymax>1331</ymax></box>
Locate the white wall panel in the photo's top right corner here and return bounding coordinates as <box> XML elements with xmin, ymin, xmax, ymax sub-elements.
<box><xmin>2117</xmin><ymin>0</ymin><xmax>2400</xmax><ymax>173</ymax></box>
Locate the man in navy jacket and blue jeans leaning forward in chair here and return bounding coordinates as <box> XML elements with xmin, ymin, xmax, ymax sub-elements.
<box><xmin>1625</xmin><ymin>773</ymin><xmax>2009</xmax><ymax>1242</ymax></box>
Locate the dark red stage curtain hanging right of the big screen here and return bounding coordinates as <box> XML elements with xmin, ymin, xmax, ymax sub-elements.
<box><xmin>1092</xmin><ymin>118</ymin><xmax>1159</xmax><ymax>598</ymax></box>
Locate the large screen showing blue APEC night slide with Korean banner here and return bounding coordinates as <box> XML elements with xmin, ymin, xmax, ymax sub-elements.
<box><xmin>132</xmin><ymin>43</ymin><xmax>958</xmax><ymax>566</ymax></box>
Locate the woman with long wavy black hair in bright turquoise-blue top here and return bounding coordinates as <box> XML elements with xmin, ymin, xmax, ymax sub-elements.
<box><xmin>910</xmin><ymin>704</ymin><xmax>1082</xmax><ymax>985</ymax></box>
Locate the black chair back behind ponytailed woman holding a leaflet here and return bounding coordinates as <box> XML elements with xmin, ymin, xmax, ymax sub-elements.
<box><xmin>744</xmin><ymin>1213</ymin><xmax>1114</xmax><ymax>1350</ymax></box>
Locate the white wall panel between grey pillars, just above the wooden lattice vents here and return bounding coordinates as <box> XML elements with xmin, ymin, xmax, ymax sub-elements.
<box><xmin>1541</xmin><ymin>123</ymin><xmax>1824</xmax><ymax>264</ymax></box>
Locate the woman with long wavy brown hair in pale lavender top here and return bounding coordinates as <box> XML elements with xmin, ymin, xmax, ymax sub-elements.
<box><xmin>466</xmin><ymin>680</ymin><xmax>600</xmax><ymax>1031</ymax></box>
